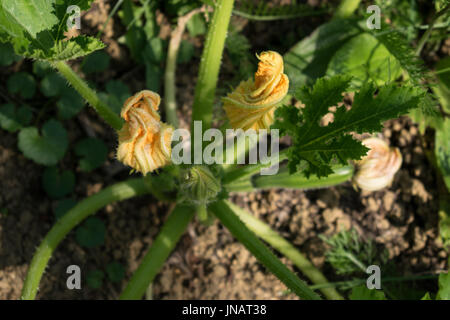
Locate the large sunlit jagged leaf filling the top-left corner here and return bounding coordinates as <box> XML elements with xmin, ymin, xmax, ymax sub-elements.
<box><xmin>0</xmin><ymin>0</ymin><xmax>104</xmax><ymax>61</ymax></box>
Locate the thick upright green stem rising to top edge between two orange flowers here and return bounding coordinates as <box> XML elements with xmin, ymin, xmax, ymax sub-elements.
<box><xmin>191</xmin><ymin>0</ymin><xmax>234</xmax><ymax>133</ymax></box>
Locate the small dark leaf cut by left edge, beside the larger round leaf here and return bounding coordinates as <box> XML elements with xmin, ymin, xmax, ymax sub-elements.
<box><xmin>0</xmin><ymin>103</ymin><xmax>33</xmax><ymax>132</ymax></box>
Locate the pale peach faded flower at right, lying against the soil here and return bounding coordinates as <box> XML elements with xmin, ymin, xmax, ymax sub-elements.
<box><xmin>353</xmin><ymin>137</ymin><xmax>402</xmax><ymax>191</ymax></box>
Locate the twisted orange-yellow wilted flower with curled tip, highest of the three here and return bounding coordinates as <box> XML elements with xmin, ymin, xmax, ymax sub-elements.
<box><xmin>222</xmin><ymin>51</ymin><xmax>289</xmax><ymax>131</ymax></box>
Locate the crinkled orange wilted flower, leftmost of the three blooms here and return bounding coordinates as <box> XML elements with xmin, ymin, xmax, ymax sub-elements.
<box><xmin>117</xmin><ymin>90</ymin><xmax>173</xmax><ymax>175</ymax></box>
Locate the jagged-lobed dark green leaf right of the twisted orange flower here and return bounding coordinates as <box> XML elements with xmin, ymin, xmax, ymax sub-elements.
<box><xmin>273</xmin><ymin>76</ymin><xmax>420</xmax><ymax>177</ymax></box>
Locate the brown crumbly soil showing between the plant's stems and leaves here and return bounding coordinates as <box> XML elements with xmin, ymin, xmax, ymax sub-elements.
<box><xmin>0</xmin><ymin>1</ymin><xmax>448</xmax><ymax>299</ymax></box>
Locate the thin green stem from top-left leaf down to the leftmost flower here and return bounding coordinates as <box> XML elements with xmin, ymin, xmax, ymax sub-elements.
<box><xmin>52</xmin><ymin>61</ymin><xmax>123</xmax><ymax>130</ymax></box>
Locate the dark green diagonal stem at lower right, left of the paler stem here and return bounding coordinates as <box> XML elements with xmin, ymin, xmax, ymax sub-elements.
<box><xmin>209</xmin><ymin>201</ymin><xmax>320</xmax><ymax>300</ymax></box>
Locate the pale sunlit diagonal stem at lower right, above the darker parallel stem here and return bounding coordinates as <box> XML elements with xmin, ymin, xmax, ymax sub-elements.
<box><xmin>228</xmin><ymin>202</ymin><xmax>344</xmax><ymax>300</ymax></box>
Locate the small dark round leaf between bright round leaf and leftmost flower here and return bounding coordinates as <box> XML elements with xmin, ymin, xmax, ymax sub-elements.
<box><xmin>75</xmin><ymin>138</ymin><xmax>108</xmax><ymax>171</ymax></box>
